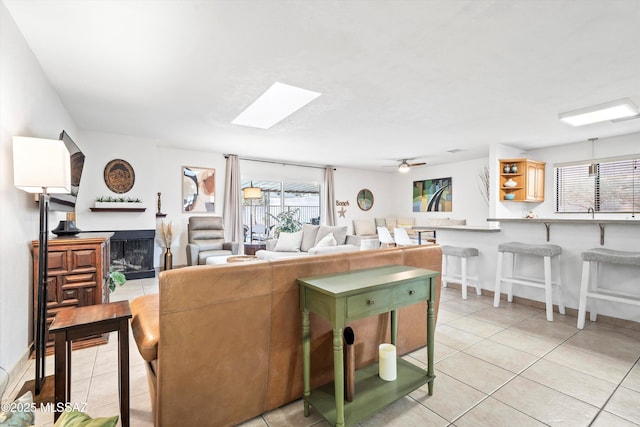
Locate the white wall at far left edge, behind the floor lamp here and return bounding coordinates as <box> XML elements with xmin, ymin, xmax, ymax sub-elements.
<box><xmin>0</xmin><ymin>3</ymin><xmax>77</xmax><ymax>391</ymax></box>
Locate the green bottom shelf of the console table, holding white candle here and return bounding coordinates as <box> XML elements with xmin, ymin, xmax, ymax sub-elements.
<box><xmin>305</xmin><ymin>359</ymin><xmax>435</xmax><ymax>426</ymax></box>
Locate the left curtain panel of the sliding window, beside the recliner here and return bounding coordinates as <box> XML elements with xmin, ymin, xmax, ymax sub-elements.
<box><xmin>223</xmin><ymin>154</ymin><xmax>244</xmax><ymax>243</ymax></box>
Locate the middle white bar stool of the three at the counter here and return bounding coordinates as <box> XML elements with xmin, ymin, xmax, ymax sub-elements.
<box><xmin>493</xmin><ymin>242</ymin><xmax>565</xmax><ymax>322</ymax></box>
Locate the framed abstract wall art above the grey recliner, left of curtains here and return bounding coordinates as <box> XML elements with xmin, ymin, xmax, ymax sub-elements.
<box><xmin>182</xmin><ymin>166</ymin><xmax>216</xmax><ymax>213</ymax></box>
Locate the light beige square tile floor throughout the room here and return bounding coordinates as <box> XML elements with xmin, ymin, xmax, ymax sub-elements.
<box><xmin>5</xmin><ymin>279</ymin><xmax>640</xmax><ymax>427</ymax></box>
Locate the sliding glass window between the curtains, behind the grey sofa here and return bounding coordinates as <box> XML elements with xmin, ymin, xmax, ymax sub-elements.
<box><xmin>242</xmin><ymin>180</ymin><xmax>320</xmax><ymax>240</ymax></box>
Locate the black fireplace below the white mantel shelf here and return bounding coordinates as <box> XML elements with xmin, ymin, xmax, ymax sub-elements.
<box><xmin>110</xmin><ymin>230</ymin><xmax>156</xmax><ymax>280</ymax></box>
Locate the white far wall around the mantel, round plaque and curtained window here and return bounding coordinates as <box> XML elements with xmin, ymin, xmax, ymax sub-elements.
<box><xmin>72</xmin><ymin>142</ymin><xmax>393</xmax><ymax>267</ymax></box>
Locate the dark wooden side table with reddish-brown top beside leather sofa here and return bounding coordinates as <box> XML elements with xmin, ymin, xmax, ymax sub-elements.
<box><xmin>49</xmin><ymin>301</ymin><xmax>131</xmax><ymax>427</ymax></box>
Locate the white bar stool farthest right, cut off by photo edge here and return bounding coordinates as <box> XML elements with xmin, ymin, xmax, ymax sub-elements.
<box><xmin>578</xmin><ymin>248</ymin><xmax>640</xmax><ymax>329</ymax></box>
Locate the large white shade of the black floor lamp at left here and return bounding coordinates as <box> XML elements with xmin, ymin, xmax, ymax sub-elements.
<box><xmin>13</xmin><ymin>136</ymin><xmax>71</xmax><ymax>193</ymax></box>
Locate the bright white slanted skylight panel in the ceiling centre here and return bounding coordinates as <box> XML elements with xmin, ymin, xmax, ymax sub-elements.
<box><xmin>231</xmin><ymin>82</ymin><xmax>322</xmax><ymax>129</ymax></box>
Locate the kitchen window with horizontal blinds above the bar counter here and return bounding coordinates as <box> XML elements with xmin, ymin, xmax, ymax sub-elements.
<box><xmin>555</xmin><ymin>156</ymin><xmax>640</xmax><ymax>213</ymax></box>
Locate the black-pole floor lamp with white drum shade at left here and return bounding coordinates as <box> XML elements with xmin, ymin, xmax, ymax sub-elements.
<box><xmin>13</xmin><ymin>136</ymin><xmax>71</xmax><ymax>395</ymax></box>
